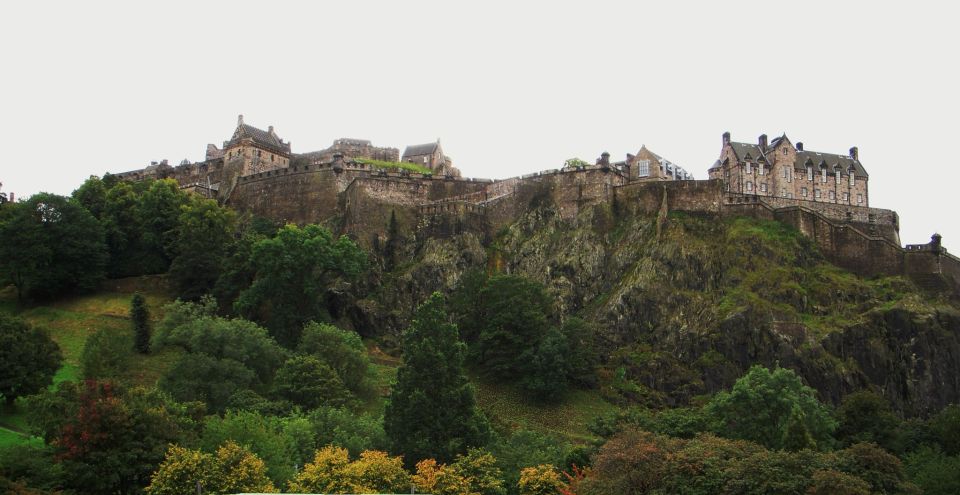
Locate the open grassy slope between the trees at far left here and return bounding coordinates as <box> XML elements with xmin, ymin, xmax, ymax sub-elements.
<box><xmin>0</xmin><ymin>284</ymin><xmax>176</xmax><ymax>446</ymax></box>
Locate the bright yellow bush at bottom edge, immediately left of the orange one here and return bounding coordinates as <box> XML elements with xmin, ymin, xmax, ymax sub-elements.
<box><xmin>289</xmin><ymin>445</ymin><xmax>411</xmax><ymax>493</ymax></box>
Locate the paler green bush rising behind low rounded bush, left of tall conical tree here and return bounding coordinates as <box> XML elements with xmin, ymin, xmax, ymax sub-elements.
<box><xmin>297</xmin><ymin>322</ymin><xmax>375</xmax><ymax>397</ymax></box>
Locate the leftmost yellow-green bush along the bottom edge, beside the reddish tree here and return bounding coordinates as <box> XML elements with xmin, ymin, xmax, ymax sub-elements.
<box><xmin>146</xmin><ymin>442</ymin><xmax>277</xmax><ymax>495</ymax></box>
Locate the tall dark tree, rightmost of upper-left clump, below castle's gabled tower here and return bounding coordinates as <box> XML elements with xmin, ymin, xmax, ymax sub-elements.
<box><xmin>170</xmin><ymin>196</ymin><xmax>236</xmax><ymax>300</ymax></box>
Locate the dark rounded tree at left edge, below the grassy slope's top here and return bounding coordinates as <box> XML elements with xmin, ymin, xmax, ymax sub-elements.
<box><xmin>0</xmin><ymin>313</ymin><xmax>63</xmax><ymax>404</ymax></box>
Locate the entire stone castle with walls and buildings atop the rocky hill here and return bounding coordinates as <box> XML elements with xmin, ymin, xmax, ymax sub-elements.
<box><xmin>117</xmin><ymin>115</ymin><xmax>960</xmax><ymax>295</ymax></box>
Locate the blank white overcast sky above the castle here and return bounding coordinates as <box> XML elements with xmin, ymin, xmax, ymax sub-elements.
<box><xmin>0</xmin><ymin>0</ymin><xmax>960</xmax><ymax>247</ymax></box>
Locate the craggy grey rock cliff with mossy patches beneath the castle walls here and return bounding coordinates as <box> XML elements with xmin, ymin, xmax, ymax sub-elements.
<box><xmin>337</xmin><ymin>192</ymin><xmax>960</xmax><ymax>415</ymax></box>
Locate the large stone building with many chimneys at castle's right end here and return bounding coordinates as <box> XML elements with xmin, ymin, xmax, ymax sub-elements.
<box><xmin>708</xmin><ymin>132</ymin><xmax>870</xmax><ymax>207</ymax></box>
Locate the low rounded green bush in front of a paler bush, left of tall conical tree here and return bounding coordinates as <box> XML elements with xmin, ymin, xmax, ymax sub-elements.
<box><xmin>273</xmin><ymin>356</ymin><xmax>351</xmax><ymax>409</ymax></box>
